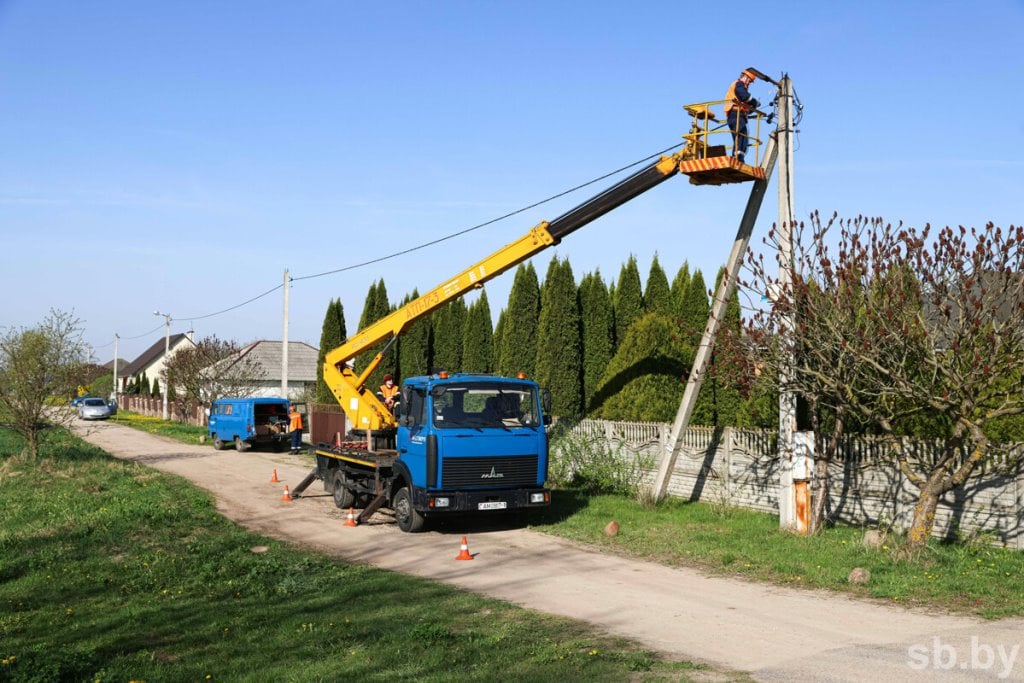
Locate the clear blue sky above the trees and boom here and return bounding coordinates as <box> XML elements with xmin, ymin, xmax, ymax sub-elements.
<box><xmin>0</xmin><ymin>0</ymin><xmax>1024</xmax><ymax>361</ymax></box>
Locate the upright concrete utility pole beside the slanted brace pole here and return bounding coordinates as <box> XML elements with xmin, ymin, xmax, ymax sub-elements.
<box><xmin>776</xmin><ymin>76</ymin><xmax>811</xmax><ymax>533</ymax></box>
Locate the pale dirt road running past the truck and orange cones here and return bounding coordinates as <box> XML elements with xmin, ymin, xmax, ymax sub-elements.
<box><xmin>73</xmin><ymin>423</ymin><xmax>1024</xmax><ymax>681</ymax></box>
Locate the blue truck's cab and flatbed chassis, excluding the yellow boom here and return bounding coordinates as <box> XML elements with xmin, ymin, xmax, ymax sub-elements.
<box><xmin>313</xmin><ymin>372</ymin><xmax>551</xmax><ymax>531</ymax></box>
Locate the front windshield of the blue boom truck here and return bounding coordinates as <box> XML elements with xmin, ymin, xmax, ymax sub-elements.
<box><xmin>432</xmin><ymin>382</ymin><xmax>541</xmax><ymax>429</ymax></box>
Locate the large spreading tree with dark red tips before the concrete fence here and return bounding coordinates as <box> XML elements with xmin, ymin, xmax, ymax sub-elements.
<box><xmin>744</xmin><ymin>214</ymin><xmax>1024</xmax><ymax>550</ymax></box>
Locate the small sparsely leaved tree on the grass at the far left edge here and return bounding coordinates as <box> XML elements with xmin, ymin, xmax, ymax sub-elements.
<box><xmin>0</xmin><ymin>309</ymin><xmax>89</xmax><ymax>458</ymax></box>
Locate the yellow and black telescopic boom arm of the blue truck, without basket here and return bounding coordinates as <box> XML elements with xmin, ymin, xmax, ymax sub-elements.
<box><xmin>324</xmin><ymin>153</ymin><xmax>682</xmax><ymax>430</ymax></box>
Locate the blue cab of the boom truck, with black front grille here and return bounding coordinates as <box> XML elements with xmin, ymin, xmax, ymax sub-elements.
<box><xmin>395</xmin><ymin>373</ymin><xmax>550</xmax><ymax>528</ymax></box>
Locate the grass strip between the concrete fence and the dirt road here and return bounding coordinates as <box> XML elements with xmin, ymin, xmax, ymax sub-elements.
<box><xmin>531</xmin><ymin>490</ymin><xmax>1024</xmax><ymax>618</ymax></box>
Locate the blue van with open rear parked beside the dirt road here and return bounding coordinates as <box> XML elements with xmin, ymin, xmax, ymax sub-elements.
<box><xmin>208</xmin><ymin>398</ymin><xmax>290</xmax><ymax>452</ymax></box>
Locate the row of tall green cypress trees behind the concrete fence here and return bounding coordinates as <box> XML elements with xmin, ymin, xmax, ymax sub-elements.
<box><xmin>317</xmin><ymin>255</ymin><xmax>774</xmax><ymax>426</ymax></box>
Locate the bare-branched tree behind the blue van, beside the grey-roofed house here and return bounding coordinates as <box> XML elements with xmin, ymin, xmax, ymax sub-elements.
<box><xmin>161</xmin><ymin>336</ymin><xmax>266</xmax><ymax>414</ymax></box>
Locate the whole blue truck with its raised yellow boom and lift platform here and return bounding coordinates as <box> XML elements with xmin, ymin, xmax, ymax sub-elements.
<box><xmin>293</xmin><ymin>137</ymin><xmax>745</xmax><ymax>531</ymax></box>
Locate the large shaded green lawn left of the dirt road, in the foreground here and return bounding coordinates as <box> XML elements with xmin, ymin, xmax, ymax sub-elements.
<box><xmin>0</xmin><ymin>429</ymin><xmax>720</xmax><ymax>681</ymax></box>
